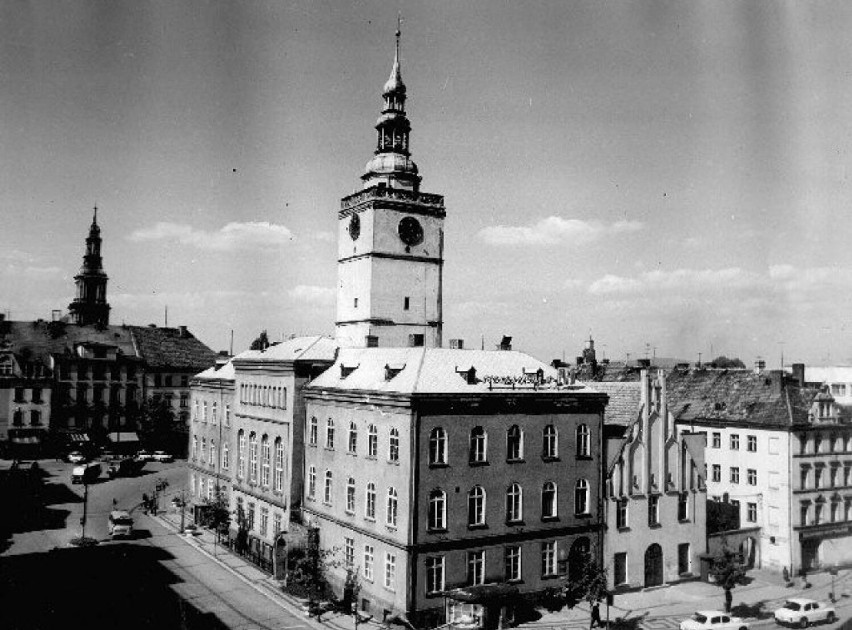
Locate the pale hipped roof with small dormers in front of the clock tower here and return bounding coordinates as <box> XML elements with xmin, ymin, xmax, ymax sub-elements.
<box><xmin>310</xmin><ymin>348</ymin><xmax>590</xmax><ymax>394</ymax></box>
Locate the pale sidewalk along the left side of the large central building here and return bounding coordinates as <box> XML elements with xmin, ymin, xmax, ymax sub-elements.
<box><xmin>148</xmin><ymin>511</ymin><xmax>386</xmax><ymax>630</ymax></box>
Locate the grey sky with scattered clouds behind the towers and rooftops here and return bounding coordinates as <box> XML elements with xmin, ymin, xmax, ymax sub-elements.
<box><xmin>0</xmin><ymin>0</ymin><xmax>852</xmax><ymax>367</ymax></box>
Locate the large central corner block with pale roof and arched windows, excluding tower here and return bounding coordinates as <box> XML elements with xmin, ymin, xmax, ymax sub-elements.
<box><xmin>303</xmin><ymin>348</ymin><xmax>606</xmax><ymax>625</ymax></box>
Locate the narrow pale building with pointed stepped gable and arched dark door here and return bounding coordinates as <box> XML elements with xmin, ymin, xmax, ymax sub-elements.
<box><xmin>590</xmin><ymin>370</ymin><xmax>707</xmax><ymax>589</ymax></box>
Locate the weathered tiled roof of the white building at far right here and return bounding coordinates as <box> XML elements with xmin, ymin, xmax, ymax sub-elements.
<box><xmin>666</xmin><ymin>369</ymin><xmax>819</xmax><ymax>426</ymax></box>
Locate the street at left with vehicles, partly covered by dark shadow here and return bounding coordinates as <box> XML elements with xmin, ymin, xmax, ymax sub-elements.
<box><xmin>0</xmin><ymin>461</ymin><xmax>307</xmax><ymax>630</ymax></box>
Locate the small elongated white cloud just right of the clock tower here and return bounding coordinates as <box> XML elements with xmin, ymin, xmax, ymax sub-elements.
<box><xmin>478</xmin><ymin>216</ymin><xmax>643</xmax><ymax>246</ymax></box>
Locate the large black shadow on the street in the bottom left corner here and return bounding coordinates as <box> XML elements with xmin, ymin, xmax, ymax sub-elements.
<box><xmin>0</xmin><ymin>543</ymin><xmax>233</xmax><ymax>630</ymax></box>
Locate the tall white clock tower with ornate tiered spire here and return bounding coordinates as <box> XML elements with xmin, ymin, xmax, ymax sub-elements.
<box><xmin>336</xmin><ymin>28</ymin><xmax>446</xmax><ymax>348</ymax></box>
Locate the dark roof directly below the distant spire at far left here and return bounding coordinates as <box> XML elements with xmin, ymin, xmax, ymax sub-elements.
<box><xmin>0</xmin><ymin>320</ymin><xmax>136</xmax><ymax>369</ymax></box>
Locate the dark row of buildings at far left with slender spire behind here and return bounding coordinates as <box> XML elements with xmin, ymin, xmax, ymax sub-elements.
<box><xmin>0</xmin><ymin>209</ymin><xmax>216</xmax><ymax>455</ymax></box>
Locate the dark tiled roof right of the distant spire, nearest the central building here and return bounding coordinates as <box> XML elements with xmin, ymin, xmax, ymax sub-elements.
<box><xmin>127</xmin><ymin>326</ymin><xmax>217</xmax><ymax>370</ymax></box>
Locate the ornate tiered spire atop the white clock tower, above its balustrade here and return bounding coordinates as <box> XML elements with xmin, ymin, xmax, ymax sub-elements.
<box><xmin>361</xmin><ymin>21</ymin><xmax>420</xmax><ymax>191</ymax></box>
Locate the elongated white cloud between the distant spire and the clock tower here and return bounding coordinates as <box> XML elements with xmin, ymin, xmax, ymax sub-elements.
<box><xmin>127</xmin><ymin>221</ymin><xmax>295</xmax><ymax>251</ymax></box>
